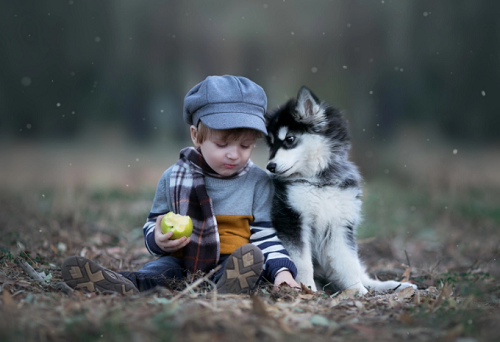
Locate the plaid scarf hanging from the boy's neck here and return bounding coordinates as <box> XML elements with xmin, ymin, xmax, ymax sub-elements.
<box><xmin>170</xmin><ymin>147</ymin><xmax>253</xmax><ymax>273</ymax></box>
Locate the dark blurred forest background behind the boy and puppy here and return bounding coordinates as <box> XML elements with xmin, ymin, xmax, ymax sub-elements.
<box><xmin>0</xmin><ymin>0</ymin><xmax>500</xmax><ymax>186</ymax></box>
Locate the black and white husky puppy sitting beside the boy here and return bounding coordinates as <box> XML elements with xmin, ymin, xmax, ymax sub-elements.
<box><xmin>266</xmin><ymin>87</ymin><xmax>416</xmax><ymax>295</ymax></box>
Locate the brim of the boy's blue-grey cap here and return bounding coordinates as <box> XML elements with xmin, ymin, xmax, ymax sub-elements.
<box><xmin>200</xmin><ymin>113</ymin><xmax>267</xmax><ymax>135</ymax></box>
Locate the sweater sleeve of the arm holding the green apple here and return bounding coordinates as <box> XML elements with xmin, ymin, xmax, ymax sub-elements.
<box><xmin>142</xmin><ymin>169</ymin><xmax>172</xmax><ymax>256</ymax></box>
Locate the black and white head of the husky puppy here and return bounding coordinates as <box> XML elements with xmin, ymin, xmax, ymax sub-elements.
<box><xmin>266</xmin><ymin>87</ymin><xmax>350</xmax><ymax>177</ymax></box>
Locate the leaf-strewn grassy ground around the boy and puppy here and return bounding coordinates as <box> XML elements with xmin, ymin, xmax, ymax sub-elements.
<box><xmin>0</xmin><ymin>138</ymin><xmax>500</xmax><ymax>342</ymax></box>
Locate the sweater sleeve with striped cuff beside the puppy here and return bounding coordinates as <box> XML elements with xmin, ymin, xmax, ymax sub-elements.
<box><xmin>250</xmin><ymin>172</ymin><xmax>297</xmax><ymax>283</ymax></box>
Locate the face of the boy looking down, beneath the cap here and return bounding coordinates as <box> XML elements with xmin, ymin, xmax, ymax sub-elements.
<box><xmin>191</xmin><ymin>126</ymin><xmax>256</xmax><ymax>176</ymax></box>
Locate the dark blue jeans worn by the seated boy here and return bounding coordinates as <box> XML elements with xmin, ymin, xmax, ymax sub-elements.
<box><xmin>120</xmin><ymin>254</ymin><xmax>229</xmax><ymax>292</ymax></box>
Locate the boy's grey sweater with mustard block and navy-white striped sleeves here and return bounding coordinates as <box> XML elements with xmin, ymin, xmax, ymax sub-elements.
<box><xmin>143</xmin><ymin>165</ymin><xmax>297</xmax><ymax>282</ymax></box>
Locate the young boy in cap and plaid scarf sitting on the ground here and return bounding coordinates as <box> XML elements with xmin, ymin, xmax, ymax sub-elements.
<box><xmin>62</xmin><ymin>75</ymin><xmax>298</xmax><ymax>294</ymax></box>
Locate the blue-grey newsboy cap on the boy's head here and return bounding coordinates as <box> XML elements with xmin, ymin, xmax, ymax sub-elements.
<box><xmin>183</xmin><ymin>75</ymin><xmax>267</xmax><ymax>134</ymax></box>
